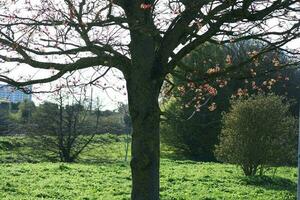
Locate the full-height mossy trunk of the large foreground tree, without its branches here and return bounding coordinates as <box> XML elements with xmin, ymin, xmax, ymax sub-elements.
<box><xmin>125</xmin><ymin>5</ymin><xmax>164</xmax><ymax>195</ymax></box>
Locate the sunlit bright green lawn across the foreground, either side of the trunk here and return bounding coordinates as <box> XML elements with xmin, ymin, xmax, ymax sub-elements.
<box><xmin>0</xmin><ymin>135</ymin><xmax>297</xmax><ymax>200</ymax></box>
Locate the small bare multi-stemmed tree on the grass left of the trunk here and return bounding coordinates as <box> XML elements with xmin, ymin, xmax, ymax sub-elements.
<box><xmin>30</xmin><ymin>95</ymin><xmax>99</xmax><ymax>162</ymax></box>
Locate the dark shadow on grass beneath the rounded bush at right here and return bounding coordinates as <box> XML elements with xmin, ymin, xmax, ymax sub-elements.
<box><xmin>242</xmin><ymin>176</ymin><xmax>297</xmax><ymax>192</ymax></box>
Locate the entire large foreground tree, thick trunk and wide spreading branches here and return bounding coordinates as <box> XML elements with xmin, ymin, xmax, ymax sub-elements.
<box><xmin>0</xmin><ymin>0</ymin><xmax>299</xmax><ymax>200</ymax></box>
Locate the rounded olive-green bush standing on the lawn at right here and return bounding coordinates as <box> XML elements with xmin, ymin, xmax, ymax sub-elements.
<box><xmin>215</xmin><ymin>94</ymin><xmax>297</xmax><ymax>176</ymax></box>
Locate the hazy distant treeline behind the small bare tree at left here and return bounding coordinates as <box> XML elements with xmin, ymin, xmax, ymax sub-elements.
<box><xmin>0</xmin><ymin>101</ymin><xmax>128</xmax><ymax>135</ymax></box>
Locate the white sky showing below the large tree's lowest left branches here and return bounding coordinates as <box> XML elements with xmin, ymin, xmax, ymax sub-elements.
<box><xmin>0</xmin><ymin>63</ymin><xmax>127</xmax><ymax>110</ymax></box>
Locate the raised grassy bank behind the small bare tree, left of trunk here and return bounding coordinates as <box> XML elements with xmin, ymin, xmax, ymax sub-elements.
<box><xmin>0</xmin><ymin>134</ymin><xmax>130</xmax><ymax>163</ymax></box>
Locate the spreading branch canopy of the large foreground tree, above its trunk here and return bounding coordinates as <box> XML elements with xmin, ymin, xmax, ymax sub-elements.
<box><xmin>0</xmin><ymin>0</ymin><xmax>299</xmax><ymax>87</ymax></box>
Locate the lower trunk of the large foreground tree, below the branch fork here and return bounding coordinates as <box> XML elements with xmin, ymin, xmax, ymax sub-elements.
<box><xmin>127</xmin><ymin>67</ymin><xmax>161</xmax><ymax>200</ymax></box>
